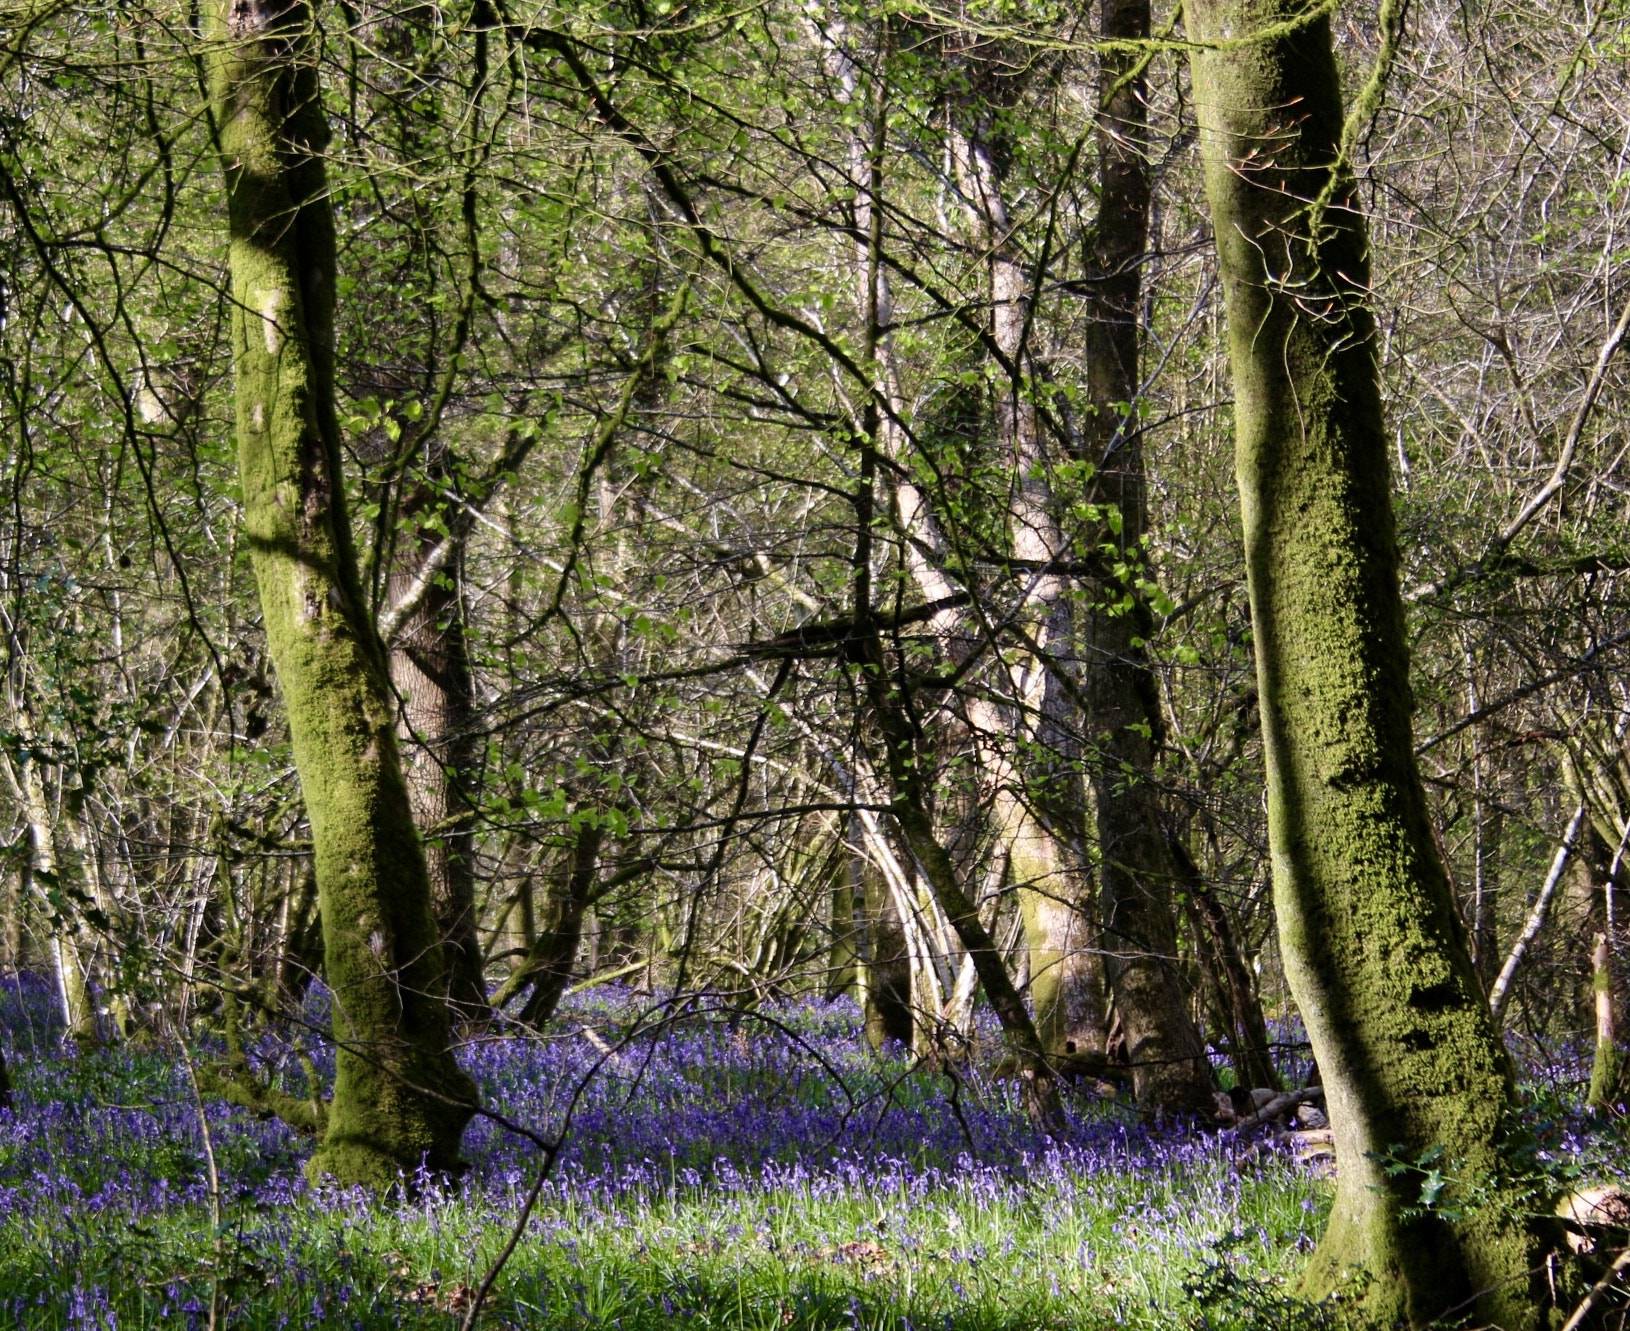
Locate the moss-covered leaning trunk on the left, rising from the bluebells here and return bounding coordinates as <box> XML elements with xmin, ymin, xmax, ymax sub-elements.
<box><xmin>210</xmin><ymin>0</ymin><xmax>474</xmax><ymax>1186</ymax></box>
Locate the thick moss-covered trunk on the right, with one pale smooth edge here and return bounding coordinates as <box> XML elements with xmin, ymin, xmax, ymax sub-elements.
<box><xmin>1185</xmin><ymin>0</ymin><xmax>1544</xmax><ymax>1331</ymax></box>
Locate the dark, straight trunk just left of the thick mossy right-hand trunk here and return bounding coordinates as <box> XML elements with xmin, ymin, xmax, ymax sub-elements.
<box><xmin>1082</xmin><ymin>0</ymin><xmax>1214</xmax><ymax>1114</ymax></box>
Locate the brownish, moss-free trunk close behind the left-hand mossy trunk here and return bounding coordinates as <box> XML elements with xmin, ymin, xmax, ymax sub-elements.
<box><xmin>390</xmin><ymin>531</ymin><xmax>492</xmax><ymax>1023</ymax></box>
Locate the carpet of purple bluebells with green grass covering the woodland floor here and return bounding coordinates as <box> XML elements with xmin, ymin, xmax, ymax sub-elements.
<box><xmin>0</xmin><ymin>976</ymin><xmax>1590</xmax><ymax>1331</ymax></box>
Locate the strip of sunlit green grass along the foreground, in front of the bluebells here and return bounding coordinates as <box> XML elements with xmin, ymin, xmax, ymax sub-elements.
<box><xmin>0</xmin><ymin>1107</ymin><xmax>1327</xmax><ymax>1331</ymax></box>
